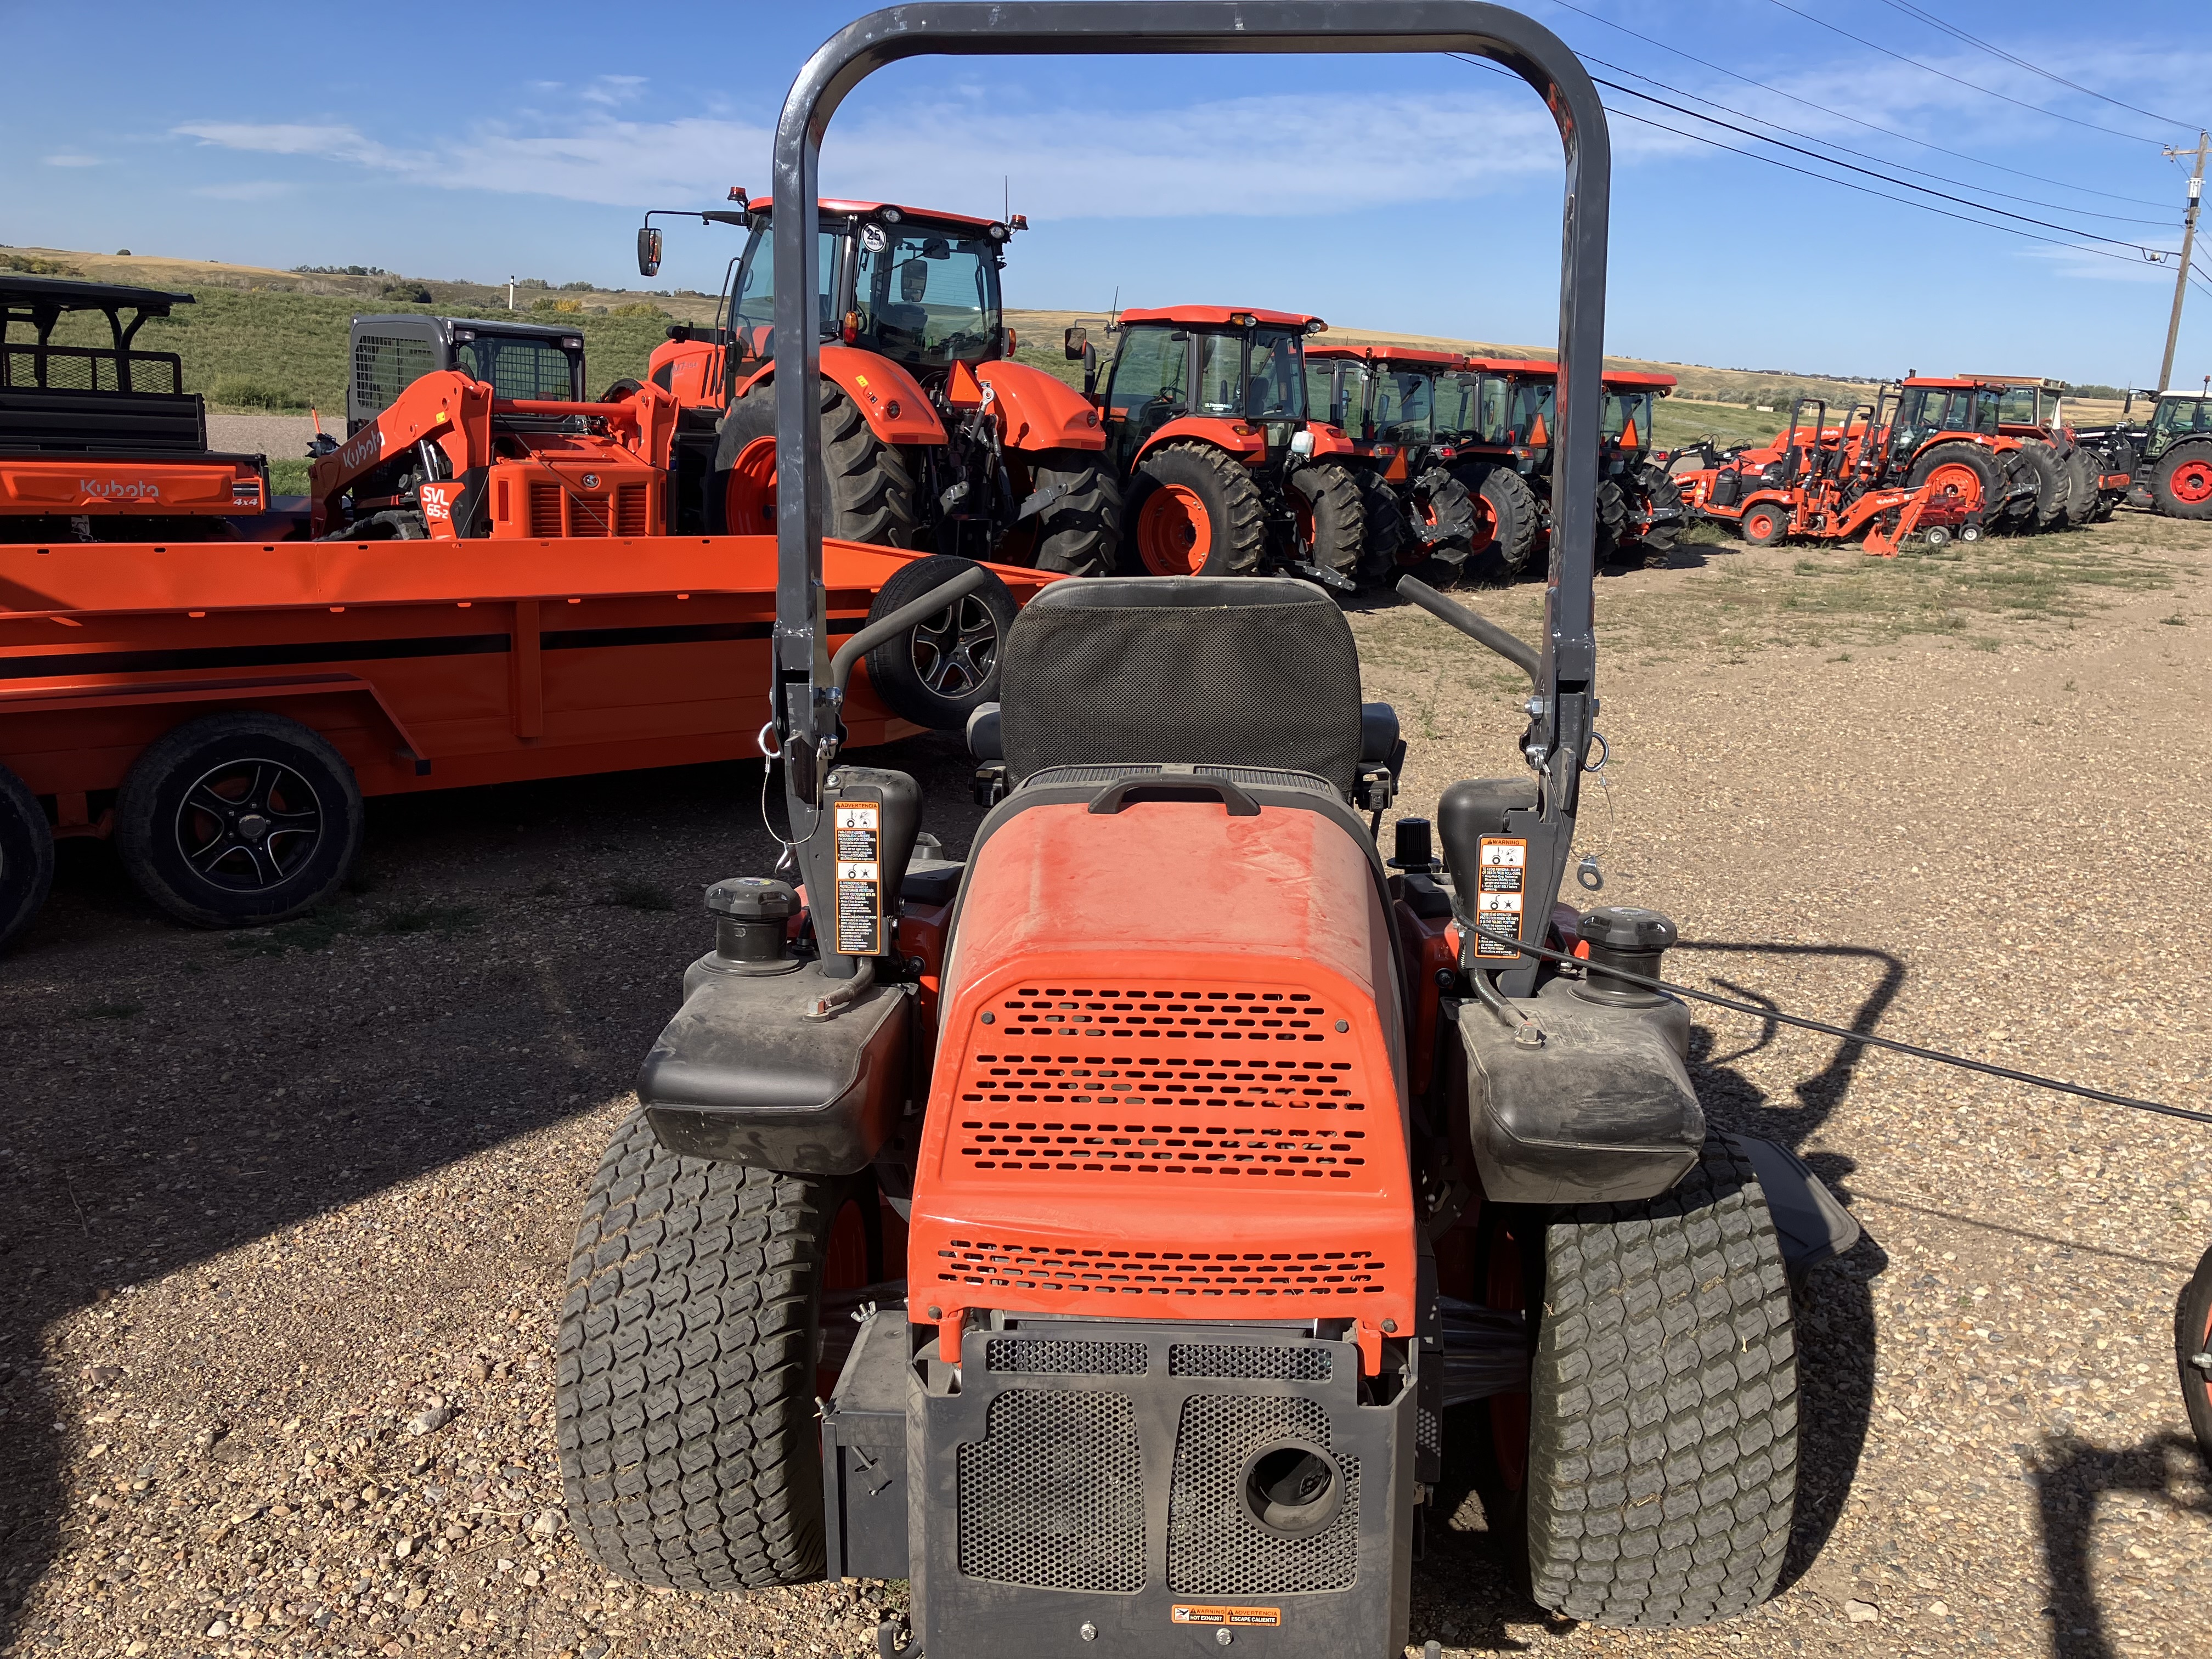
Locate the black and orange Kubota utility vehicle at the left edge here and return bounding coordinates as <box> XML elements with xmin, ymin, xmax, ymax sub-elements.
<box><xmin>0</xmin><ymin>276</ymin><xmax>290</xmax><ymax>542</ymax></box>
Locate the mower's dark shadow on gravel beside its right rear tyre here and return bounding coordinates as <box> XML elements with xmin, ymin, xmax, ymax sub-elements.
<box><xmin>1674</xmin><ymin>940</ymin><xmax>1905</xmax><ymax>1588</ymax></box>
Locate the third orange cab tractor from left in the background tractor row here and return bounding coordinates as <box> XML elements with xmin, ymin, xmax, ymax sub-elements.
<box><xmin>1305</xmin><ymin>345</ymin><xmax>1475</xmax><ymax>582</ymax></box>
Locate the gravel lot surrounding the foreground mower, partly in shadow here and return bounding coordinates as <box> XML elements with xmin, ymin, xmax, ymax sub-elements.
<box><xmin>0</xmin><ymin>517</ymin><xmax>2212</xmax><ymax>1659</ymax></box>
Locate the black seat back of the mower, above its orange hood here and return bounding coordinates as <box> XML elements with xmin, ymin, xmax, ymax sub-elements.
<box><xmin>969</xmin><ymin>575</ymin><xmax>1398</xmax><ymax>799</ymax></box>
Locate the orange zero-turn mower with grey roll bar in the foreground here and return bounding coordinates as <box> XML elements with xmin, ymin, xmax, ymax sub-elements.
<box><xmin>557</xmin><ymin>0</ymin><xmax>1847</xmax><ymax>1659</ymax></box>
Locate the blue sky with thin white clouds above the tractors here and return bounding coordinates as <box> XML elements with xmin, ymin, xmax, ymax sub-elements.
<box><xmin>0</xmin><ymin>0</ymin><xmax>2212</xmax><ymax>385</ymax></box>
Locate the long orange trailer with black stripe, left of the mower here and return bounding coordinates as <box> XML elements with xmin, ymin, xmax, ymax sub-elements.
<box><xmin>0</xmin><ymin>535</ymin><xmax>1053</xmax><ymax>945</ymax></box>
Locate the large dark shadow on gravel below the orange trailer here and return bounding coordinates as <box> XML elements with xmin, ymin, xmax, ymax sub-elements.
<box><xmin>0</xmin><ymin>739</ymin><xmax>980</xmax><ymax>1650</ymax></box>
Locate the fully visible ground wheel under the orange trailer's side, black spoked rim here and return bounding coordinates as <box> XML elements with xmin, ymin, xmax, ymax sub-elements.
<box><xmin>115</xmin><ymin>710</ymin><xmax>360</xmax><ymax>927</ymax></box>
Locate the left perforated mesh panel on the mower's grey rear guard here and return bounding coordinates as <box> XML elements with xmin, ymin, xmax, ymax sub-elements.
<box><xmin>958</xmin><ymin>1389</ymin><xmax>1144</xmax><ymax>1590</ymax></box>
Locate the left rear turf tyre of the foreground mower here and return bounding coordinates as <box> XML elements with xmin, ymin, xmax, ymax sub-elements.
<box><xmin>553</xmin><ymin>1110</ymin><xmax>851</xmax><ymax>1590</ymax></box>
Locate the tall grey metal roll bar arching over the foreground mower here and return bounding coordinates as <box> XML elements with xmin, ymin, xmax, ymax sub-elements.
<box><xmin>772</xmin><ymin>0</ymin><xmax>1612</xmax><ymax>978</ymax></box>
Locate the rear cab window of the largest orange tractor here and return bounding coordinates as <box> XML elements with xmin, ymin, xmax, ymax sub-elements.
<box><xmin>851</xmin><ymin>223</ymin><xmax>1002</xmax><ymax>367</ymax></box>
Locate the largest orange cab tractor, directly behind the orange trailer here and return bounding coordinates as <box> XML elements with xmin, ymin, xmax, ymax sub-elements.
<box><xmin>637</xmin><ymin>190</ymin><xmax>1121</xmax><ymax>575</ymax></box>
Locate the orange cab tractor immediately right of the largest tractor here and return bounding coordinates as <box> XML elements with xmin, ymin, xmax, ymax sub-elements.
<box><xmin>1088</xmin><ymin>305</ymin><xmax>1367</xmax><ymax>591</ymax></box>
